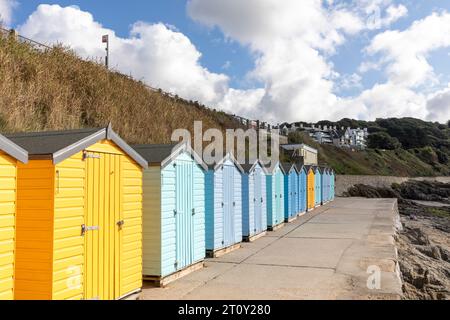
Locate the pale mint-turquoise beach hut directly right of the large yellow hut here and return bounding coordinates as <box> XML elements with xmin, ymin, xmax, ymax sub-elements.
<box><xmin>134</xmin><ymin>143</ymin><xmax>208</xmax><ymax>286</ymax></box>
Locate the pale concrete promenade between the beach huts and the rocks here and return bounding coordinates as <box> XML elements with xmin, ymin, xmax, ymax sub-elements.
<box><xmin>140</xmin><ymin>198</ymin><xmax>402</xmax><ymax>300</ymax></box>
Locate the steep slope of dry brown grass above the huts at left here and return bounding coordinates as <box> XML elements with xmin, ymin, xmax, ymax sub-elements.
<box><xmin>0</xmin><ymin>36</ymin><xmax>243</xmax><ymax>143</ymax></box>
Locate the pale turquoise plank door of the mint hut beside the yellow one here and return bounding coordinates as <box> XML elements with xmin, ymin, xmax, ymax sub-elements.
<box><xmin>175</xmin><ymin>160</ymin><xmax>195</xmax><ymax>270</ymax></box>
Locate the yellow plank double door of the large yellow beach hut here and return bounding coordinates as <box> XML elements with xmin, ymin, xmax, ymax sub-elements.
<box><xmin>82</xmin><ymin>152</ymin><xmax>124</xmax><ymax>300</ymax></box>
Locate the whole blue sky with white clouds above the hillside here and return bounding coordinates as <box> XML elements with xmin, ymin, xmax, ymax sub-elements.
<box><xmin>0</xmin><ymin>0</ymin><xmax>450</xmax><ymax>122</ymax></box>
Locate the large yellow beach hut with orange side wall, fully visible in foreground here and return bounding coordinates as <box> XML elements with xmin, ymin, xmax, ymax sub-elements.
<box><xmin>8</xmin><ymin>126</ymin><xmax>147</xmax><ymax>300</ymax></box>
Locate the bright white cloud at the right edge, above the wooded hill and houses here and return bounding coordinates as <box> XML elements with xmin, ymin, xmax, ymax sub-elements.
<box><xmin>352</xmin><ymin>12</ymin><xmax>450</xmax><ymax>122</ymax></box>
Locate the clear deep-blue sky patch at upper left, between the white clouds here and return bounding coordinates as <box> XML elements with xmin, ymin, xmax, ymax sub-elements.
<box><xmin>9</xmin><ymin>0</ymin><xmax>253</xmax><ymax>87</ymax></box>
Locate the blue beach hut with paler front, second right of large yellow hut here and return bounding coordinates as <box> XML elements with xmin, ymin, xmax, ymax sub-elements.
<box><xmin>205</xmin><ymin>154</ymin><xmax>244</xmax><ymax>257</ymax></box>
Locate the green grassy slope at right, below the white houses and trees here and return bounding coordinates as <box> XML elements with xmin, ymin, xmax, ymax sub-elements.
<box><xmin>290</xmin><ymin>133</ymin><xmax>450</xmax><ymax>176</ymax></box>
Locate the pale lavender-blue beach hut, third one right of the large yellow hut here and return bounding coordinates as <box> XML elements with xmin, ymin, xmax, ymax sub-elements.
<box><xmin>242</xmin><ymin>160</ymin><xmax>267</xmax><ymax>241</ymax></box>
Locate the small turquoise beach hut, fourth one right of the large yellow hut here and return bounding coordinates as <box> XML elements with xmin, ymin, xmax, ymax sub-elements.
<box><xmin>266</xmin><ymin>162</ymin><xmax>285</xmax><ymax>231</ymax></box>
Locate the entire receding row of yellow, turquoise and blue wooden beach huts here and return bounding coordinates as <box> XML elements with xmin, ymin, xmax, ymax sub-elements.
<box><xmin>0</xmin><ymin>126</ymin><xmax>334</xmax><ymax>300</ymax></box>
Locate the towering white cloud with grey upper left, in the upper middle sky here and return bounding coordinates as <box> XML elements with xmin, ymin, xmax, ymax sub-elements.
<box><xmin>187</xmin><ymin>0</ymin><xmax>370</xmax><ymax>121</ymax></box>
